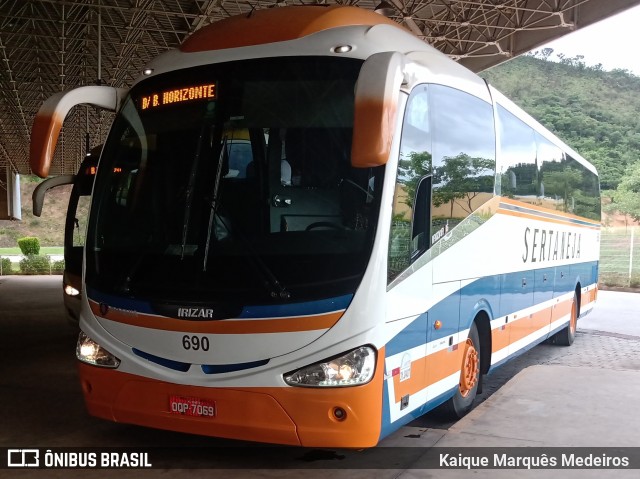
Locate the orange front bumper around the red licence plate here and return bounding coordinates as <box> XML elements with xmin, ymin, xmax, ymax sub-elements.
<box><xmin>78</xmin><ymin>351</ymin><xmax>384</xmax><ymax>448</ymax></box>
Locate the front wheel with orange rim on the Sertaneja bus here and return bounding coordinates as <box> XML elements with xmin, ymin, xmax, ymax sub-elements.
<box><xmin>443</xmin><ymin>322</ymin><xmax>481</xmax><ymax>419</ymax></box>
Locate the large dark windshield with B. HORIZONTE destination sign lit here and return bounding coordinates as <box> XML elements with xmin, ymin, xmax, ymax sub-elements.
<box><xmin>86</xmin><ymin>57</ymin><xmax>384</xmax><ymax>304</ymax></box>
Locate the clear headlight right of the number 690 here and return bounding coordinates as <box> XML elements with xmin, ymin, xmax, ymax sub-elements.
<box><xmin>284</xmin><ymin>346</ymin><xmax>376</xmax><ymax>387</ymax></box>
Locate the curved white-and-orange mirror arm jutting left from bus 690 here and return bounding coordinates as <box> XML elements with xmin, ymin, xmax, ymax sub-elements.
<box><xmin>29</xmin><ymin>86</ymin><xmax>126</xmax><ymax>178</ymax></box>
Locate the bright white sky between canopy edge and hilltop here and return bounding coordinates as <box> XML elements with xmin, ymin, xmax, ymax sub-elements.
<box><xmin>535</xmin><ymin>3</ymin><xmax>640</xmax><ymax>75</ymax></box>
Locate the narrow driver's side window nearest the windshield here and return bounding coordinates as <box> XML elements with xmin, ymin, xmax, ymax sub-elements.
<box><xmin>388</xmin><ymin>85</ymin><xmax>431</xmax><ymax>281</ymax></box>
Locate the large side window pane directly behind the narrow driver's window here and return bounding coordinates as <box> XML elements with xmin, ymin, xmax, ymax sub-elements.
<box><xmin>429</xmin><ymin>85</ymin><xmax>495</xmax><ymax>244</ymax></box>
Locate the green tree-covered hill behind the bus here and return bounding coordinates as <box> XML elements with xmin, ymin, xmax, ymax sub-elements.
<box><xmin>482</xmin><ymin>49</ymin><xmax>640</xmax><ymax>190</ymax></box>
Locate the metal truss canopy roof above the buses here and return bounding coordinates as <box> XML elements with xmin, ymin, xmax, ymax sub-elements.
<box><xmin>0</xmin><ymin>0</ymin><xmax>640</xmax><ymax>178</ymax></box>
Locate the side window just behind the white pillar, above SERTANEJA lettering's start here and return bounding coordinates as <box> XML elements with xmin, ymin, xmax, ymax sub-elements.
<box><xmin>496</xmin><ymin>105</ymin><xmax>539</xmax><ymax>204</ymax></box>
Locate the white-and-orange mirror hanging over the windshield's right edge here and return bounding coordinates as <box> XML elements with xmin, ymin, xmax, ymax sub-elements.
<box><xmin>351</xmin><ymin>52</ymin><xmax>405</xmax><ymax>168</ymax></box>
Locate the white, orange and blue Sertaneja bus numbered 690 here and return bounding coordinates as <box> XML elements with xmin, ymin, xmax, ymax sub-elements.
<box><xmin>31</xmin><ymin>6</ymin><xmax>600</xmax><ymax>448</ymax></box>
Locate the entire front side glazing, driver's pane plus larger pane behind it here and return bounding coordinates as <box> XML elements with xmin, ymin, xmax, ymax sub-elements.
<box><xmin>388</xmin><ymin>85</ymin><xmax>495</xmax><ymax>281</ymax></box>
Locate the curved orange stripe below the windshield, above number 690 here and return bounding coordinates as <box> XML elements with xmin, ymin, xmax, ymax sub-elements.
<box><xmin>89</xmin><ymin>301</ymin><xmax>344</xmax><ymax>334</ymax></box>
